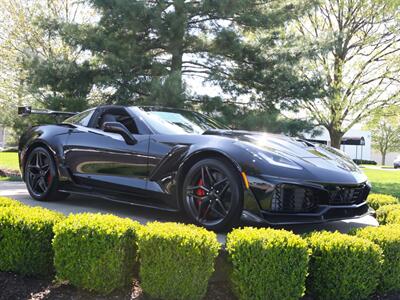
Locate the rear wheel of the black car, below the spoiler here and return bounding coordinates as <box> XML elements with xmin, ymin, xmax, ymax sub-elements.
<box><xmin>24</xmin><ymin>147</ymin><xmax>68</xmax><ymax>201</ymax></box>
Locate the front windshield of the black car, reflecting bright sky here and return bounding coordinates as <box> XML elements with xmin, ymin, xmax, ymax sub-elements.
<box><xmin>134</xmin><ymin>107</ymin><xmax>229</xmax><ymax>134</ymax></box>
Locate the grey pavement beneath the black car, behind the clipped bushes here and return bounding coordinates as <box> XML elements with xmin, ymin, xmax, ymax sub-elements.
<box><xmin>0</xmin><ymin>181</ymin><xmax>378</xmax><ymax>243</ymax></box>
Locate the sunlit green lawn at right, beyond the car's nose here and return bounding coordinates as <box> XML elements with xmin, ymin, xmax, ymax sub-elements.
<box><xmin>363</xmin><ymin>168</ymin><xmax>400</xmax><ymax>199</ymax></box>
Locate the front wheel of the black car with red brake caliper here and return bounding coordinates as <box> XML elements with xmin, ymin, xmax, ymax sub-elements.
<box><xmin>182</xmin><ymin>158</ymin><xmax>243</xmax><ymax>231</ymax></box>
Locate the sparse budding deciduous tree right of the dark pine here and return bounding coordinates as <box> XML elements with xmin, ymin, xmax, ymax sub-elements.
<box><xmin>295</xmin><ymin>0</ymin><xmax>400</xmax><ymax>148</ymax></box>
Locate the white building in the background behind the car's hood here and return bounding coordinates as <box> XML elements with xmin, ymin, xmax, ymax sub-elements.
<box><xmin>305</xmin><ymin>128</ymin><xmax>371</xmax><ymax>160</ymax></box>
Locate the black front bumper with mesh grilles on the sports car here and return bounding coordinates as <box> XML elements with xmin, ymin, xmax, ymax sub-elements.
<box><xmin>242</xmin><ymin>173</ymin><xmax>374</xmax><ymax>225</ymax></box>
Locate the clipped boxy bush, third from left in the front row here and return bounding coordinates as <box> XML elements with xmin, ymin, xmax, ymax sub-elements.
<box><xmin>138</xmin><ymin>222</ymin><xmax>220</xmax><ymax>299</ymax></box>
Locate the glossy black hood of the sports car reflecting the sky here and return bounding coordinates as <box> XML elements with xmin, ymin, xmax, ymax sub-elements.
<box><xmin>204</xmin><ymin>130</ymin><xmax>361</xmax><ymax>173</ymax></box>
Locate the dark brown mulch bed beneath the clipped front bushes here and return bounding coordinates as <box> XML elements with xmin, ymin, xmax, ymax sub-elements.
<box><xmin>0</xmin><ymin>272</ymin><xmax>235</xmax><ymax>300</ymax></box>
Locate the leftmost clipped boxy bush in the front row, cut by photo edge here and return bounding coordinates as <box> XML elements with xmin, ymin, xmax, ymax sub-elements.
<box><xmin>0</xmin><ymin>205</ymin><xmax>63</xmax><ymax>275</ymax></box>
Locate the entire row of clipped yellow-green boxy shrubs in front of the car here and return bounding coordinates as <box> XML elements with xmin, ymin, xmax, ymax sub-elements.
<box><xmin>0</xmin><ymin>198</ymin><xmax>400</xmax><ymax>299</ymax></box>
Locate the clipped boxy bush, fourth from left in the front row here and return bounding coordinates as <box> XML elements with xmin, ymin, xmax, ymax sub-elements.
<box><xmin>226</xmin><ymin>227</ymin><xmax>309</xmax><ymax>299</ymax></box>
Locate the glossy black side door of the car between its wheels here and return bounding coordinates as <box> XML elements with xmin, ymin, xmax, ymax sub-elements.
<box><xmin>64</xmin><ymin>107</ymin><xmax>149</xmax><ymax>195</ymax></box>
